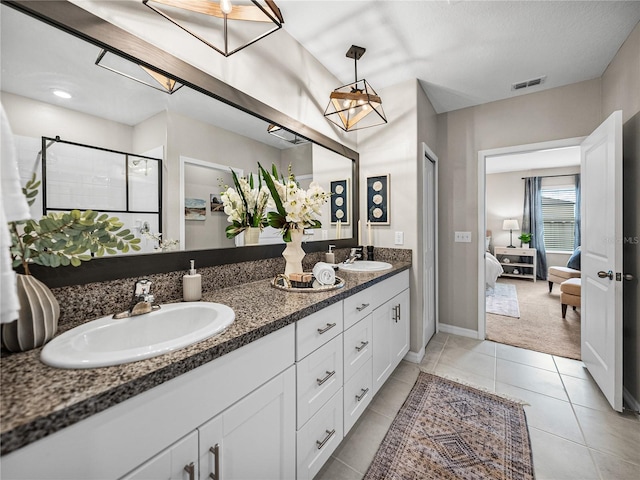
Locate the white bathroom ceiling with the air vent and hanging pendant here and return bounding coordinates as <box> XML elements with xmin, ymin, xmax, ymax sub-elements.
<box><xmin>276</xmin><ymin>0</ymin><xmax>640</xmax><ymax>113</ymax></box>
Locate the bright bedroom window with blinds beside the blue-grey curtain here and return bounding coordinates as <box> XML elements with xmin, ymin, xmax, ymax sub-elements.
<box><xmin>542</xmin><ymin>185</ymin><xmax>576</xmax><ymax>252</ymax></box>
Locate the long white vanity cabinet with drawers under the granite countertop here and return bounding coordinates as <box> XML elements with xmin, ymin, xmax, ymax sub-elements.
<box><xmin>0</xmin><ymin>271</ymin><xmax>409</xmax><ymax>480</ymax></box>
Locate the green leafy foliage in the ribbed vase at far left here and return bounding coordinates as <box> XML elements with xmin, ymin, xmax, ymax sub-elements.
<box><xmin>9</xmin><ymin>174</ymin><xmax>140</xmax><ymax>275</ymax></box>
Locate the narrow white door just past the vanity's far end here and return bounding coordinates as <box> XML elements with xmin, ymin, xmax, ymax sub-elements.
<box><xmin>423</xmin><ymin>152</ymin><xmax>436</xmax><ymax>345</ymax></box>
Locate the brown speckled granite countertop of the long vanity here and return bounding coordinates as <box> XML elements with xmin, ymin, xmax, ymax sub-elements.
<box><xmin>0</xmin><ymin>262</ymin><xmax>411</xmax><ymax>454</ymax></box>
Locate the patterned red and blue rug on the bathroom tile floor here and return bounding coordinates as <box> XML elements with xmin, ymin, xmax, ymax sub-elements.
<box><xmin>364</xmin><ymin>372</ymin><xmax>534</xmax><ymax>480</ymax></box>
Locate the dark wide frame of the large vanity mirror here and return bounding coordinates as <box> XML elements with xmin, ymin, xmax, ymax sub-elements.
<box><xmin>2</xmin><ymin>0</ymin><xmax>360</xmax><ymax>288</ymax></box>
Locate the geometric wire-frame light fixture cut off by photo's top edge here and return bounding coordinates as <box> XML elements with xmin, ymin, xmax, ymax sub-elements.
<box><xmin>142</xmin><ymin>0</ymin><xmax>284</xmax><ymax>57</ymax></box>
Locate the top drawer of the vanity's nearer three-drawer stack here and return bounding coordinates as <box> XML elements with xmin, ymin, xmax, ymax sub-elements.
<box><xmin>296</xmin><ymin>302</ymin><xmax>344</xmax><ymax>361</ymax></box>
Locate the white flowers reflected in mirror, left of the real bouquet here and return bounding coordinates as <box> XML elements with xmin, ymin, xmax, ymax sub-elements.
<box><xmin>221</xmin><ymin>170</ymin><xmax>269</xmax><ymax>238</ymax></box>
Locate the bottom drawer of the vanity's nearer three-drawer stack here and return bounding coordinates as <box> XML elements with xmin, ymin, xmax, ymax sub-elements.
<box><xmin>296</xmin><ymin>388</ymin><xmax>343</xmax><ymax>480</ymax></box>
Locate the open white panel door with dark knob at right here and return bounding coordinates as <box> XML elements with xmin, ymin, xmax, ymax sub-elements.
<box><xmin>580</xmin><ymin>111</ymin><xmax>622</xmax><ymax>411</ymax></box>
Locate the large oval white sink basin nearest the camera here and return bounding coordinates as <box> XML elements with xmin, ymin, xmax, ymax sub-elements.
<box><xmin>40</xmin><ymin>302</ymin><xmax>235</xmax><ymax>368</ymax></box>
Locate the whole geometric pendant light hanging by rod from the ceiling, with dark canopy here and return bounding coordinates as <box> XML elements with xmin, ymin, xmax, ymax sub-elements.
<box><xmin>324</xmin><ymin>45</ymin><xmax>387</xmax><ymax>132</ymax></box>
